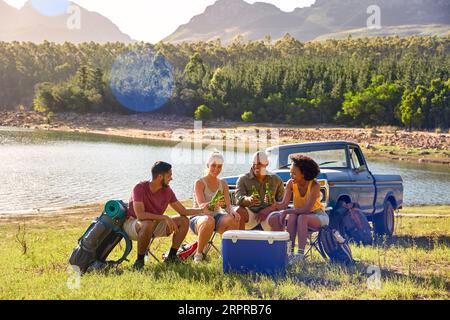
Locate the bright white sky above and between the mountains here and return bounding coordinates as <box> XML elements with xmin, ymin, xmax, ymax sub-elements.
<box><xmin>4</xmin><ymin>0</ymin><xmax>315</xmax><ymax>43</ymax></box>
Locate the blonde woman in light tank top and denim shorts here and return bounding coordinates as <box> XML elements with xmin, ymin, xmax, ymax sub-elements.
<box><xmin>190</xmin><ymin>152</ymin><xmax>240</xmax><ymax>263</ymax></box>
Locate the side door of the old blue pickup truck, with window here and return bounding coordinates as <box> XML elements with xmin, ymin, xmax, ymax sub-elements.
<box><xmin>349</xmin><ymin>146</ymin><xmax>375</xmax><ymax>214</ymax></box>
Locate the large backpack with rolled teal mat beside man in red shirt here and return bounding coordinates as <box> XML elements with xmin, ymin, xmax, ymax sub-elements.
<box><xmin>69</xmin><ymin>201</ymin><xmax>133</xmax><ymax>274</ymax></box>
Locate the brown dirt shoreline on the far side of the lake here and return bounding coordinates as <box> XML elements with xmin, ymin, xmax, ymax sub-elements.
<box><xmin>0</xmin><ymin>112</ymin><xmax>450</xmax><ymax>165</ymax></box>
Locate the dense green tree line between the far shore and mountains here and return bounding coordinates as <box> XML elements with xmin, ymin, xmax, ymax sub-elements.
<box><xmin>0</xmin><ymin>34</ymin><xmax>450</xmax><ymax>129</ymax></box>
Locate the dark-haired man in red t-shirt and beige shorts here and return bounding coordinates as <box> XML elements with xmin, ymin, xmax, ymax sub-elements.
<box><xmin>123</xmin><ymin>162</ymin><xmax>211</xmax><ymax>270</ymax></box>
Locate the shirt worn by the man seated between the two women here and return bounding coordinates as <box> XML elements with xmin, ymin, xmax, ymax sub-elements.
<box><xmin>235</xmin><ymin>170</ymin><xmax>284</xmax><ymax>213</ymax></box>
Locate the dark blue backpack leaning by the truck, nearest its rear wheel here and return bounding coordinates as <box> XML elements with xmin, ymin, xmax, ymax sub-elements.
<box><xmin>330</xmin><ymin>203</ymin><xmax>372</xmax><ymax>245</ymax></box>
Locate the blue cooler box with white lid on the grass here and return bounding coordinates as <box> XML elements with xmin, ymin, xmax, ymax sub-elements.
<box><xmin>222</xmin><ymin>231</ymin><xmax>290</xmax><ymax>275</ymax></box>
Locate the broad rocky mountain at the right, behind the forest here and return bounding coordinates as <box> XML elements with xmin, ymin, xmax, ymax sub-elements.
<box><xmin>163</xmin><ymin>0</ymin><xmax>450</xmax><ymax>43</ymax></box>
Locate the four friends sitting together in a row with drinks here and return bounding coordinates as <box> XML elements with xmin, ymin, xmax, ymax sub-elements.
<box><xmin>124</xmin><ymin>151</ymin><xmax>329</xmax><ymax>270</ymax></box>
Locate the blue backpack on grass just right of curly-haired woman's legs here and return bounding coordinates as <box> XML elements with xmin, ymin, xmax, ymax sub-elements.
<box><xmin>319</xmin><ymin>227</ymin><xmax>354</xmax><ymax>265</ymax></box>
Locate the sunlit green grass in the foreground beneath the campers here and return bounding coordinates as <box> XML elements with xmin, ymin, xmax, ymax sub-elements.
<box><xmin>0</xmin><ymin>207</ymin><xmax>450</xmax><ymax>300</ymax></box>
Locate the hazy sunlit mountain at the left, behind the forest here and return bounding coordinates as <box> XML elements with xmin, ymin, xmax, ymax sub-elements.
<box><xmin>0</xmin><ymin>0</ymin><xmax>133</xmax><ymax>43</ymax></box>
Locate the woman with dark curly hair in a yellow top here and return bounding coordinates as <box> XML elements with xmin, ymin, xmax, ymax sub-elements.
<box><xmin>269</xmin><ymin>155</ymin><xmax>330</xmax><ymax>263</ymax></box>
